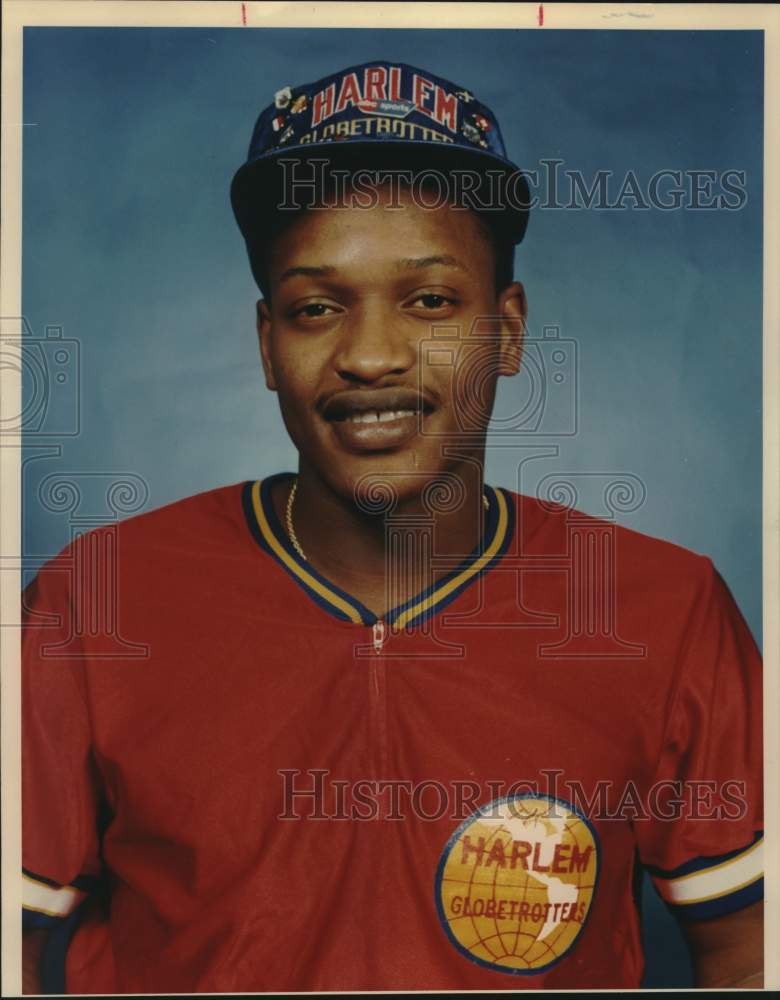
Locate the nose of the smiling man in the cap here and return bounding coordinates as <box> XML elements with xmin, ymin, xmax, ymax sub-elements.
<box><xmin>333</xmin><ymin>303</ymin><xmax>417</xmax><ymax>382</ymax></box>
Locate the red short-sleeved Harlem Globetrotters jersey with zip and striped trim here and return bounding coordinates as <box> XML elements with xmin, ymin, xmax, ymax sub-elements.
<box><xmin>22</xmin><ymin>476</ymin><xmax>763</xmax><ymax>993</ymax></box>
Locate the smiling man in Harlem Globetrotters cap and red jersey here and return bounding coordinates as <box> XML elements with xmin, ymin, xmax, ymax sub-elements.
<box><xmin>23</xmin><ymin>61</ymin><xmax>762</xmax><ymax>993</ymax></box>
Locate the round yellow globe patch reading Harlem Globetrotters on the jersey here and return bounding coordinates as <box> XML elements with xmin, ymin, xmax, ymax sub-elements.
<box><xmin>436</xmin><ymin>795</ymin><xmax>599</xmax><ymax>975</ymax></box>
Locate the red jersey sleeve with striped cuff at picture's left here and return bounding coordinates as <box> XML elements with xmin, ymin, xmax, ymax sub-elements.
<box><xmin>21</xmin><ymin>554</ymin><xmax>106</xmax><ymax>929</ymax></box>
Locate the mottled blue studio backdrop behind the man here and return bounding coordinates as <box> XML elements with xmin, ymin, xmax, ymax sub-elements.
<box><xmin>23</xmin><ymin>28</ymin><xmax>763</xmax><ymax>986</ymax></box>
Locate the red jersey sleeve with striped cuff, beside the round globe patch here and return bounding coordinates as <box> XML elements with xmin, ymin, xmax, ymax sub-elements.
<box><xmin>635</xmin><ymin>559</ymin><xmax>763</xmax><ymax>920</ymax></box>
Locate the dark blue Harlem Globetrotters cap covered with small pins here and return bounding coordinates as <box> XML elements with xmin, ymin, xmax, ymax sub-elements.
<box><xmin>225</xmin><ymin>59</ymin><xmax>530</xmax><ymax>256</ymax></box>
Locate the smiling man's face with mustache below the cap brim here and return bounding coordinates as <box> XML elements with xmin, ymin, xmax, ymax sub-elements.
<box><xmin>258</xmin><ymin>183</ymin><xmax>525</xmax><ymax>498</ymax></box>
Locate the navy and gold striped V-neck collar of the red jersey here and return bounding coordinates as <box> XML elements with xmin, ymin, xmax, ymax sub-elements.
<box><xmin>242</xmin><ymin>472</ymin><xmax>514</xmax><ymax>630</ymax></box>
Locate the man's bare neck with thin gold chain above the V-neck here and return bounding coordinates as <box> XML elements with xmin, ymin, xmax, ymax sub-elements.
<box><xmin>273</xmin><ymin>462</ymin><xmax>485</xmax><ymax>617</ymax></box>
